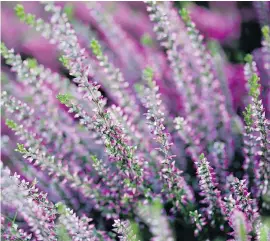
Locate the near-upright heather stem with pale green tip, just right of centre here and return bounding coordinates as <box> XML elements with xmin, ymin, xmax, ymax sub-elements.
<box><xmin>139</xmin><ymin>68</ymin><xmax>194</xmax><ymax>209</ymax></box>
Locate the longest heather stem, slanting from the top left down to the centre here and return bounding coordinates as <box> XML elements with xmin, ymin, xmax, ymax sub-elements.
<box><xmin>14</xmin><ymin>3</ymin><xmax>147</xmax><ymax>199</ymax></box>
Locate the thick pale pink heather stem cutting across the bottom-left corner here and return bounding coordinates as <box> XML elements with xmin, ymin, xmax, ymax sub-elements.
<box><xmin>1</xmin><ymin>164</ymin><xmax>57</xmax><ymax>241</ymax></box>
